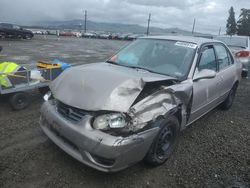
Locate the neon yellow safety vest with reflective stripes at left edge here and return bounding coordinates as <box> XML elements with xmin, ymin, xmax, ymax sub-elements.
<box><xmin>0</xmin><ymin>62</ymin><xmax>25</xmax><ymax>88</ymax></box>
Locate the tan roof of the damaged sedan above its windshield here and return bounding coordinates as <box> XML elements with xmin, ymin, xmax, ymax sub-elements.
<box><xmin>140</xmin><ymin>35</ymin><xmax>221</xmax><ymax>46</ymax></box>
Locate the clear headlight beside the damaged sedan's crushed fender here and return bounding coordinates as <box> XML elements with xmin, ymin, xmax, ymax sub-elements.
<box><xmin>93</xmin><ymin>113</ymin><xmax>127</xmax><ymax>130</ymax></box>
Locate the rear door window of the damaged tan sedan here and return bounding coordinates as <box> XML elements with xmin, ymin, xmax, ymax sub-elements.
<box><xmin>214</xmin><ymin>44</ymin><xmax>232</xmax><ymax>70</ymax></box>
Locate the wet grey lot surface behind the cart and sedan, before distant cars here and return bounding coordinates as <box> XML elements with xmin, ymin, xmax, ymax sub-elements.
<box><xmin>0</xmin><ymin>35</ymin><xmax>128</xmax><ymax>64</ymax></box>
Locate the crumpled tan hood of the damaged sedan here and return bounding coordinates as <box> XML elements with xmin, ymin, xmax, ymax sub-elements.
<box><xmin>50</xmin><ymin>63</ymin><xmax>173</xmax><ymax>112</ymax></box>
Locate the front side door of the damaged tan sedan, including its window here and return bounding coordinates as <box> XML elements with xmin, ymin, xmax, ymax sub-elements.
<box><xmin>189</xmin><ymin>44</ymin><xmax>221</xmax><ymax>123</ymax></box>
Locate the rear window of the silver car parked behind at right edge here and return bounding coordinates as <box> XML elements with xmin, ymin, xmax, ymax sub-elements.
<box><xmin>215</xmin><ymin>37</ymin><xmax>247</xmax><ymax>48</ymax></box>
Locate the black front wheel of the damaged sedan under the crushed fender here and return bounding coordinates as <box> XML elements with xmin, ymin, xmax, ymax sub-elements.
<box><xmin>144</xmin><ymin>115</ymin><xmax>180</xmax><ymax>166</ymax></box>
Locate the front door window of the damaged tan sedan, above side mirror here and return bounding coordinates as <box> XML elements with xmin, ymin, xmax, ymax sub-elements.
<box><xmin>197</xmin><ymin>46</ymin><xmax>217</xmax><ymax>71</ymax></box>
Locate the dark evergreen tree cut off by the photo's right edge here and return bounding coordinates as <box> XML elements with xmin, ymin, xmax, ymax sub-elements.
<box><xmin>237</xmin><ymin>8</ymin><xmax>250</xmax><ymax>36</ymax></box>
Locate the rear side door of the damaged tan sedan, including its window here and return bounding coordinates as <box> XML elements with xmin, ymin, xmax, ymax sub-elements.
<box><xmin>214</xmin><ymin>43</ymin><xmax>236</xmax><ymax>101</ymax></box>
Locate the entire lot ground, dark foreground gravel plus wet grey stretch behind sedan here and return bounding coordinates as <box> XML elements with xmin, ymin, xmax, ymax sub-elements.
<box><xmin>0</xmin><ymin>36</ymin><xmax>250</xmax><ymax>188</ymax></box>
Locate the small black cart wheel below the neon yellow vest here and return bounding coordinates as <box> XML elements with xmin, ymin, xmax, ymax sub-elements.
<box><xmin>9</xmin><ymin>92</ymin><xmax>30</xmax><ymax>110</ymax></box>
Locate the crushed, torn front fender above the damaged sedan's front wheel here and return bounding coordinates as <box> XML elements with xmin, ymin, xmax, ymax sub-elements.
<box><xmin>128</xmin><ymin>82</ymin><xmax>192</xmax><ymax>131</ymax></box>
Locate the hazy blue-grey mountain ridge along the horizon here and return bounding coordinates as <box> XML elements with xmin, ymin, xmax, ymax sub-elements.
<box><xmin>30</xmin><ymin>19</ymin><xmax>210</xmax><ymax>35</ymax></box>
